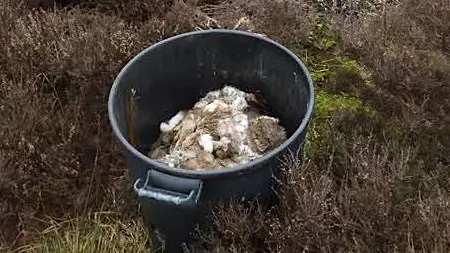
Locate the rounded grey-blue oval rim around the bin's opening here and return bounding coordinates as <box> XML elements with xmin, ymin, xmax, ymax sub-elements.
<box><xmin>108</xmin><ymin>29</ymin><xmax>314</xmax><ymax>179</ymax></box>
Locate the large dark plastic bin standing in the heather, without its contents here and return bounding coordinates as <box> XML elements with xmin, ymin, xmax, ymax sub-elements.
<box><xmin>108</xmin><ymin>30</ymin><xmax>314</xmax><ymax>252</ymax></box>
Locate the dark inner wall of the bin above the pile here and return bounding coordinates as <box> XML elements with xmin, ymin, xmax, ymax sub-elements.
<box><xmin>112</xmin><ymin>33</ymin><xmax>311</xmax><ymax>158</ymax></box>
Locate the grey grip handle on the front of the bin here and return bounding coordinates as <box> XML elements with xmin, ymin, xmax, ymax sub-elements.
<box><xmin>133</xmin><ymin>170</ymin><xmax>203</xmax><ymax>206</ymax></box>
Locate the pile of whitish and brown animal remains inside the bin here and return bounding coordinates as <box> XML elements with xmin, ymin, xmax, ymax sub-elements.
<box><xmin>149</xmin><ymin>86</ymin><xmax>286</xmax><ymax>170</ymax></box>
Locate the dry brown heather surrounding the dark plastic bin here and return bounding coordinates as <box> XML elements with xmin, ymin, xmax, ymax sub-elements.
<box><xmin>0</xmin><ymin>0</ymin><xmax>450</xmax><ymax>252</ymax></box>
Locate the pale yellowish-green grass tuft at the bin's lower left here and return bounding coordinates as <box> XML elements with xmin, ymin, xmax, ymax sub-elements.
<box><xmin>18</xmin><ymin>212</ymin><xmax>151</xmax><ymax>253</ymax></box>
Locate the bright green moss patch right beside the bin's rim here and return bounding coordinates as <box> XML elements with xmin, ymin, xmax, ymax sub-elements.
<box><xmin>290</xmin><ymin>20</ymin><xmax>376</xmax><ymax>156</ymax></box>
